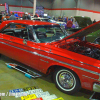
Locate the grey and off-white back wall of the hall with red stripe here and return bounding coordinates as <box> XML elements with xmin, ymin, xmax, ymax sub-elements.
<box><xmin>0</xmin><ymin>0</ymin><xmax>100</xmax><ymax>20</ymax></box>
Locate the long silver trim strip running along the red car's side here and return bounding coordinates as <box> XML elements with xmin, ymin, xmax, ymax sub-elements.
<box><xmin>0</xmin><ymin>42</ymin><xmax>100</xmax><ymax>75</ymax></box>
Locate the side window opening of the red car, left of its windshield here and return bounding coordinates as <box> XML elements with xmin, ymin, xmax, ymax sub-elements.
<box><xmin>2</xmin><ymin>23</ymin><xmax>34</xmax><ymax>41</ymax></box>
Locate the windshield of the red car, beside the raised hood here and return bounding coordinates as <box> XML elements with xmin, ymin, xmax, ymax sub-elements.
<box><xmin>33</xmin><ymin>25</ymin><xmax>67</xmax><ymax>43</ymax></box>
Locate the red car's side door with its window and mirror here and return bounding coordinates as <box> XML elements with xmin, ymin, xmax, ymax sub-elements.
<box><xmin>0</xmin><ymin>23</ymin><xmax>39</xmax><ymax>68</ymax></box>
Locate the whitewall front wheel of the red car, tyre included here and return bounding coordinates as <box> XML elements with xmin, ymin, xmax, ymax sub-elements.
<box><xmin>54</xmin><ymin>69</ymin><xmax>81</xmax><ymax>95</ymax></box>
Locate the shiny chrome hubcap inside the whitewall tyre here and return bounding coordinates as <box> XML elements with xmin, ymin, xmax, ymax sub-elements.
<box><xmin>59</xmin><ymin>72</ymin><xmax>74</xmax><ymax>89</ymax></box>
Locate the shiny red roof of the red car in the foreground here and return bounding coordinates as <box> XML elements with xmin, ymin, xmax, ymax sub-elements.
<box><xmin>2</xmin><ymin>20</ymin><xmax>58</xmax><ymax>25</ymax></box>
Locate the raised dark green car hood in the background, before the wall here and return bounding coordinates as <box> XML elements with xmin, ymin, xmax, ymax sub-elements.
<box><xmin>74</xmin><ymin>16</ymin><xmax>92</xmax><ymax>28</ymax></box>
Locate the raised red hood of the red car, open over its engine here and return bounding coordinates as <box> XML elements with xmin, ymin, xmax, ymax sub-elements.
<box><xmin>54</xmin><ymin>21</ymin><xmax>100</xmax><ymax>42</ymax></box>
